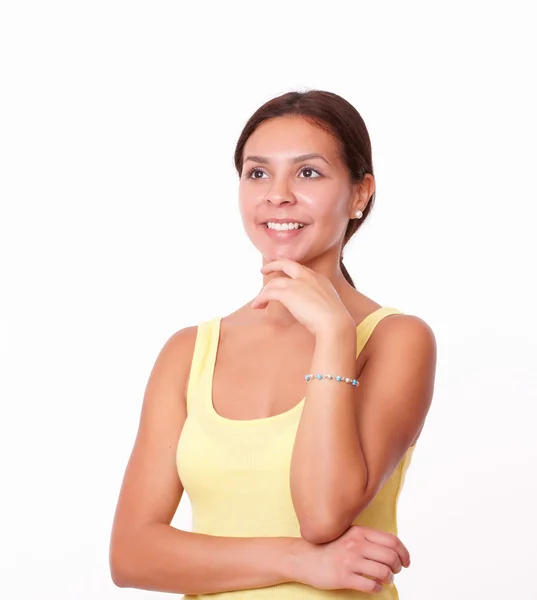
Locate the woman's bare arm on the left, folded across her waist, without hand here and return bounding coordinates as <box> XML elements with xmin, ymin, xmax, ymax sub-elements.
<box><xmin>109</xmin><ymin>327</ymin><xmax>304</xmax><ymax>594</ymax></box>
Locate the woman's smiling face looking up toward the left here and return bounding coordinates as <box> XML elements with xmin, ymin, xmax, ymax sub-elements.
<box><xmin>239</xmin><ymin>116</ymin><xmax>363</xmax><ymax>264</ymax></box>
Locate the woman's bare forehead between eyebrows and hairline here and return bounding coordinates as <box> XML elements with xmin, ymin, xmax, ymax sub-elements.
<box><xmin>244</xmin><ymin>115</ymin><xmax>338</xmax><ymax>157</ymax></box>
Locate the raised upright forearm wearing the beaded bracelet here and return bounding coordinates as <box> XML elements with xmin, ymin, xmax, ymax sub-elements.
<box><xmin>291</xmin><ymin>328</ymin><xmax>367</xmax><ymax>541</ymax></box>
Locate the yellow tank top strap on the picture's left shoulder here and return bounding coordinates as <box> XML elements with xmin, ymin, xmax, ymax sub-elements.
<box><xmin>186</xmin><ymin>317</ymin><xmax>220</xmax><ymax>413</ymax></box>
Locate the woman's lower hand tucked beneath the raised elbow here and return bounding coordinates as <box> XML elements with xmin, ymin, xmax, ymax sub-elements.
<box><xmin>292</xmin><ymin>525</ymin><xmax>410</xmax><ymax>594</ymax></box>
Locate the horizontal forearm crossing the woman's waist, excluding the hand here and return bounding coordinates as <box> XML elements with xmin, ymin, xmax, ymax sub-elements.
<box><xmin>111</xmin><ymin>524</ymin><xmax>307</xmax><ymax>594</ymax></box>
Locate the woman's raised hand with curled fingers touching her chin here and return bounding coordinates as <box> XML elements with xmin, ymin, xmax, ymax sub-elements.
<box><xmin>251</xmin><ymin>258</ymin><xmax>356</xmax><ymax>335</ymax></box>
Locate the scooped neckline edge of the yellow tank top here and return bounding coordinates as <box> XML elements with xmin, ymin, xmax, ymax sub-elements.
<box><xmin>206</xmin><ymin>306</ymin><xmax>401</xmax><ymax>427</ymax></box>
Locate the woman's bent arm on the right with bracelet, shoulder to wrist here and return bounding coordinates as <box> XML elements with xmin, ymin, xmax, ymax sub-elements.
<box><xmin>291</xmin><ymin>315</ymin><xmax>436</xmax><ymax>543</ymax></box>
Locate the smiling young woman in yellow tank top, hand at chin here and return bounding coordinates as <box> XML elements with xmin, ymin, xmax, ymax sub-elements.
<box><xmin>110</xmin><ymin>91</ymin><xmax>436</xmax><ymax>600</ymax></box>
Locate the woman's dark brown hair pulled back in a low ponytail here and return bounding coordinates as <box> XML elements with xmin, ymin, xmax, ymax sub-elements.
<box><xmin>234</xmin><ymin>90</ymin><xmax>375</xmax><ymax>288</ymax></box>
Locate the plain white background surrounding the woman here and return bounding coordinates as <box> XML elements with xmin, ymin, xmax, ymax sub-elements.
<box><xmin>0</xmin><ymin>0</ymin><xmax>537</xmax><ymax>600</ymax></box>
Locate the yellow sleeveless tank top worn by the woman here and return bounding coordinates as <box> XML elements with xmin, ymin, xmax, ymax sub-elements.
<box><xmin>176</xmin><ymin>307</ymin><xmax>414</xmax><ymax>600</ymax></box>
